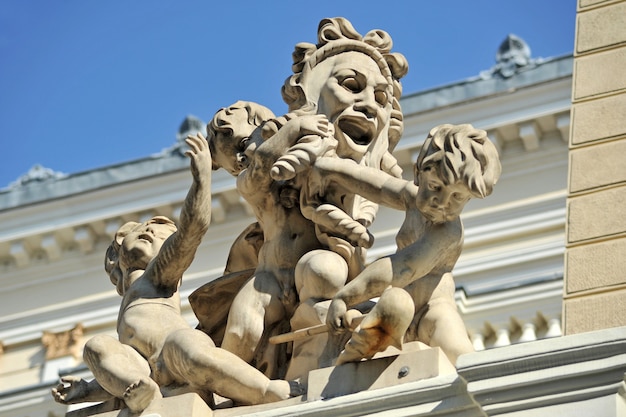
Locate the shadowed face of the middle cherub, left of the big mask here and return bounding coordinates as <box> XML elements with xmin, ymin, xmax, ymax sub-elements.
<box><xmin>211</xmin><ymin>109</ymin><xmax>262</xmax><ymax>177</ymax></box>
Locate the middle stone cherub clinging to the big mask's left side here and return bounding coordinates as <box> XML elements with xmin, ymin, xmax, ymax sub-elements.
<box><xmin>207</xmin><ymin>102</ymin><xmax>333</xmax><ymax>375</ymax></box>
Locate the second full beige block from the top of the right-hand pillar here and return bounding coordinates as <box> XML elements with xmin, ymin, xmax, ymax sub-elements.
<box><xmin>573</xmin><ymin>46</ymin><xmax>626</xmax><ymax>100</ymax></box>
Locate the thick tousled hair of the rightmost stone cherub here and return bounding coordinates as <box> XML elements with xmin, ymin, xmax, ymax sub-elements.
<box><xmin>415</xmin><ymin>124</ymin><xmax>502</xmax><ymax>198</ymax></box>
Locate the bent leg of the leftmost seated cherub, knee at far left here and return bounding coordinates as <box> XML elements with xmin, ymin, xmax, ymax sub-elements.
<box><xmin>83</xmin><ymin>335</ymin><xmax>161</xmax><ymax>412</ymax></box>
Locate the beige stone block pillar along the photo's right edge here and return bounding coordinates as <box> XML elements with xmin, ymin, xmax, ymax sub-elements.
<box><xmin>563</xmin><ymin>0</ymin><xmax>626</xmax><ymax>334</ymax></box>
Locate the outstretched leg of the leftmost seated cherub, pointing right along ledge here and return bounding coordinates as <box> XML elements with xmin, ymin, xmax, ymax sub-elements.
<box><xmin>161</xmin><ymin>329</ymin><xmax>302</xmax><ymax>404</ymax></box>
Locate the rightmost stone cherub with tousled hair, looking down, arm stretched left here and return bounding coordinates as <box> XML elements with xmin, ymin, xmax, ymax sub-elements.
<box><xmin>314</xmin><ymin>124</ymin><xmax>501</xmax><ymax>363</ymax></box>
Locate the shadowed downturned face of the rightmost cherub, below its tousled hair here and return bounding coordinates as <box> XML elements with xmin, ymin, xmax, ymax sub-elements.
<box><xmin>416</xmin><ymin>166</ymin><xmax>472</xmax><ymax>223</ymax></box>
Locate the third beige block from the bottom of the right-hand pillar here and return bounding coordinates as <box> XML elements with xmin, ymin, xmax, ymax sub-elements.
<box><xmin>567</xmin><ymin>186</ymin><xmax>626</xmax><ymax>244</ymax></box>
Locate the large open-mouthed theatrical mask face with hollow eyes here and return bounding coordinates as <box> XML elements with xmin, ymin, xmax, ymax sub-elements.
<box><xmin>313</xmin><ymin>52</ymin><xmax>393</xmax><ymax>161</ymax></box>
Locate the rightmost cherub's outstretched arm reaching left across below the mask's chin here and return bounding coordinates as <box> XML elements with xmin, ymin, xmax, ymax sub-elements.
<box><xmin>312</xmin><ymin>158</ymin><xmax>417</xmax><ymax>210</ymax></box>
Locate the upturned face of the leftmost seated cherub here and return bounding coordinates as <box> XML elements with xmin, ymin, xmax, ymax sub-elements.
<box><xmin>120</xmin><ymin>217</ymin><xmax>176</xmax><ymax>268</ymax></box>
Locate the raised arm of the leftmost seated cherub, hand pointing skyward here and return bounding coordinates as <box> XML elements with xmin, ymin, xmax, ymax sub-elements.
<box><xmin>148</xmin><ymin>133</ymin><xmax>212</xmax><ymax>286</ymax></box>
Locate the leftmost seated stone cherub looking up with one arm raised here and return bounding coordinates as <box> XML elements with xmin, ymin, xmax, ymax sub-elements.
<box><xmin>52</xmin><ymin>134</ymin><xmax>297</xmax><ymax>413</ymax></box>
